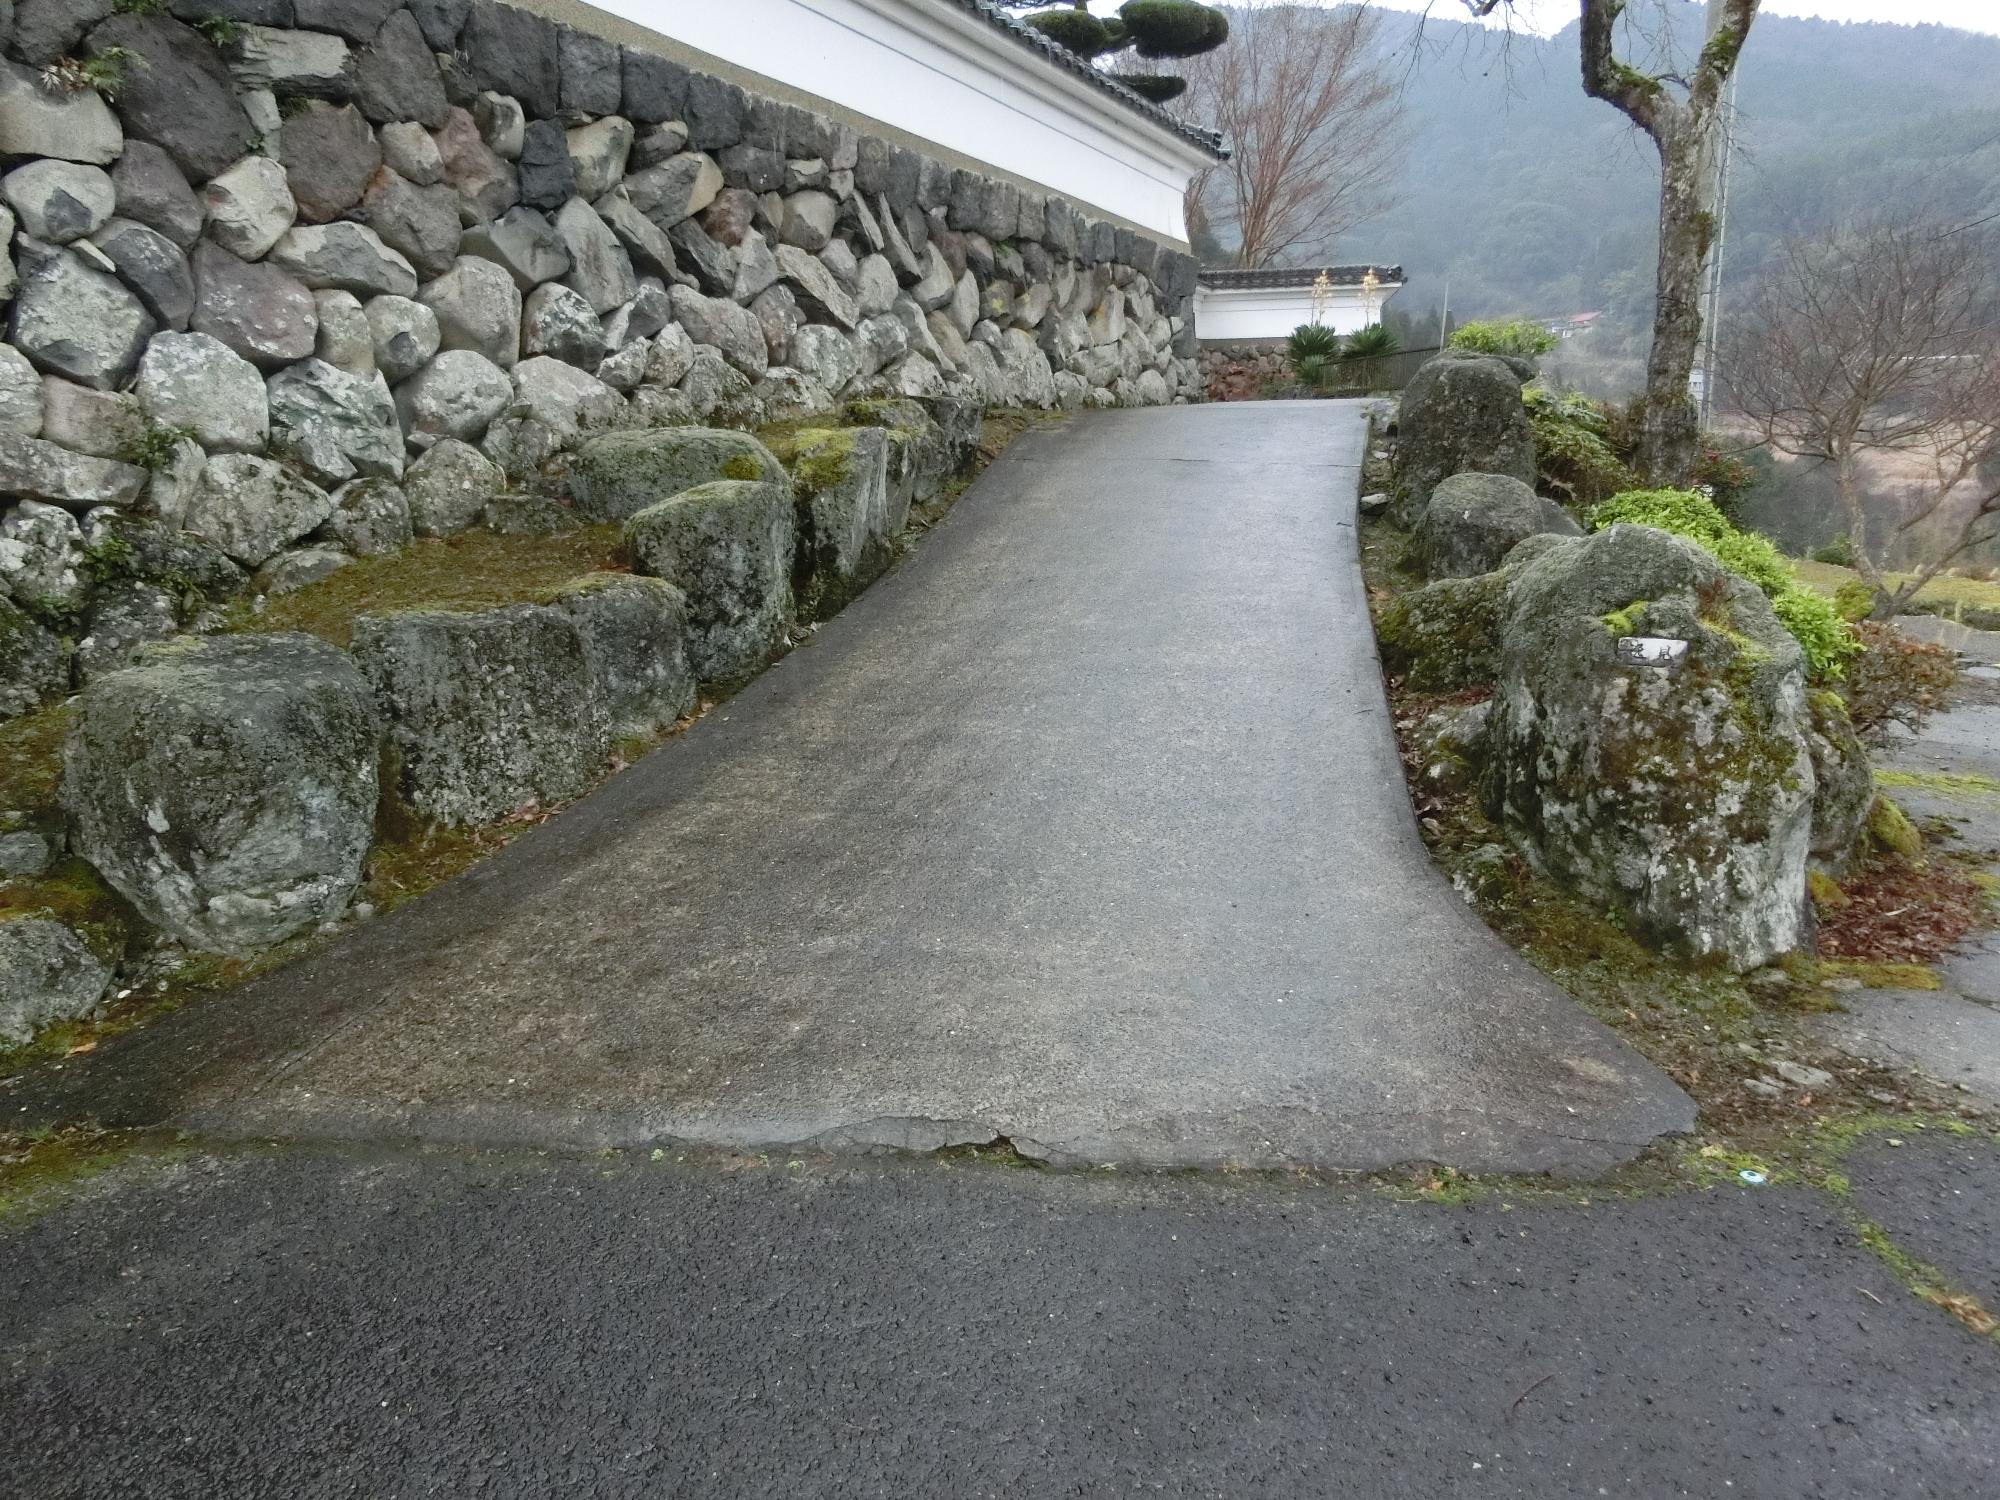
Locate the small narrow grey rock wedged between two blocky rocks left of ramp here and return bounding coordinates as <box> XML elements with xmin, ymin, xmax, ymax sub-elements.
<box><xmin>550</xmin><ymin>572</ymin><xmax>696</xmax><ymax>738</ymax></box>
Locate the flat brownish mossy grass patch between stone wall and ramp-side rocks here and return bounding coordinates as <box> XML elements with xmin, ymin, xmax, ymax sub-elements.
<box><xmin>228</xmin><ymin>526</ymin><xmax>620</xmax><ymax>650</ymax></box>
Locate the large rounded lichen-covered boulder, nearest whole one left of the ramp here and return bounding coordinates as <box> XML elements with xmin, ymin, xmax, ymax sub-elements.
<box><xmin>62</xmin><ymin>636</ymin><xmax>382</xmax><ymax>954</ymax></box>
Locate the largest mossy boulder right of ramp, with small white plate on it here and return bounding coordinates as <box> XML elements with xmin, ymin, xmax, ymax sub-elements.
<box><xmin>1486</xmin><ymin>526</ymin><xmax>1816</xmax><ymax>970</ymax></box>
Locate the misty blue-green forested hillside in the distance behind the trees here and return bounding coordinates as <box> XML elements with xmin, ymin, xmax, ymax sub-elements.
<box><xmin>1292</xmin><ymin>4</ymin><xmax>2000</xmax><ymax>394</ymax></box>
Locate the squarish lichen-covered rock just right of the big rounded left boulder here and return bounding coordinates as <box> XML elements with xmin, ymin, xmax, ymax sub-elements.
<box><xmin>354</xmin><ymin>604</ymin><xmax>610</xmax><ymax>824</ymax></box>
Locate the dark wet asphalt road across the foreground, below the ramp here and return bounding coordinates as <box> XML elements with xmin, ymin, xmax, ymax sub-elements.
<box><xmin>0</xmin><ymin>1140</ymin><xmax>2000</xmax><ymax>1500</ymax></box>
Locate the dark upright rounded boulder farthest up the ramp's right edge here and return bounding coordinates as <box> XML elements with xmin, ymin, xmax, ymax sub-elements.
<box><xmin>1394</xmin><ymin>350</ymin><xmax>1536</xmax><ymax>526</ymax></box>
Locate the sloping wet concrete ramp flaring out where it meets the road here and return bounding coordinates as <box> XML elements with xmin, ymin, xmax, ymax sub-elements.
<box><xmin>0</xmin><ymin>402</ymin><xmax>1694</xmax><ymax>1172</ymax></box>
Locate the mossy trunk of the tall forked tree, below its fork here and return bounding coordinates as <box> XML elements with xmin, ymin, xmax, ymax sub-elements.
<box><xmin>1638</xmin><ymin>122</ymin><xmax>1722</xmax><ymax>490</ymax></box>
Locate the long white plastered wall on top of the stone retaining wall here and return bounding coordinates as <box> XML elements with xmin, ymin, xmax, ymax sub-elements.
<box><xmin>592</xmin><ymin>0</ymin><xmax>1208</xmax><ymax>244</ymax></box>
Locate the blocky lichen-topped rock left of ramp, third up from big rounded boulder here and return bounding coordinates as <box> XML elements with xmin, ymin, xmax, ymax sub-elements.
<box><xmin>624</xmin><ymin>480</ymin><xmax>796</xmax><ymax>682</ymax></box>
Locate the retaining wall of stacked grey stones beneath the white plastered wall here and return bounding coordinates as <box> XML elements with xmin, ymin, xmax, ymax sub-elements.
<box><xmin>0</xmin><ymin>0</ymin><xmax>1200</xmax><ymax>716</ymax></box>
